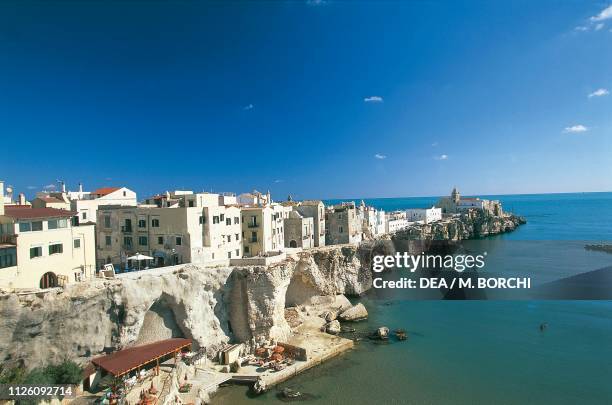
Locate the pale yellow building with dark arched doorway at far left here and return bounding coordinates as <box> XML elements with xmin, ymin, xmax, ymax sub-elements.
<box><xmin>0</xmin><ymin>182</ymin><xmax>95</xmax><ymax>290</ymax></box>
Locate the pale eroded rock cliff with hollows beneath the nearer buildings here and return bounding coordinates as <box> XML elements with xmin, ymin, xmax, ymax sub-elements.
<box><xmin>0</xmin><ymin>246</ymin><xmax>371</xmax><ymax>368</ymax></box>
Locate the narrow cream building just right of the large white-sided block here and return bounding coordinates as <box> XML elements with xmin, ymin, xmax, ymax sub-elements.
<box><xmin>239</xmin><ymin>202</ymin><xmax>292</xmax><ymax>257</ymax></box>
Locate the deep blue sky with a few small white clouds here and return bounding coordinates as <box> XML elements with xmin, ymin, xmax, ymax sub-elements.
<box><xmin>0</xmin><ymin>0</ymin><xmax>612</xmax><ymax>198</ymax></box>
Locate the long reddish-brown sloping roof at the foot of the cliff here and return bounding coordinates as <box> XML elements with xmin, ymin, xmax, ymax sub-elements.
<box><xmin>91</xmin><ymin>338</ymin><xmax>191</xmax><ymax>376</ymax></box>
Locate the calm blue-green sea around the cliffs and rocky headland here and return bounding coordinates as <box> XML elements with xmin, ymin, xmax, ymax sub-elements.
<box><xmin>213</xmin><ymin>193</ymin><xmax>612</xmax><ymax>405</ymax></box>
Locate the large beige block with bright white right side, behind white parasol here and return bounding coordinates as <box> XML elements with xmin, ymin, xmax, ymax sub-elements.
<box><xmin>97</xmin><ymin>193</ymin><xmax>242</xmax><ymax>269</ymax></box>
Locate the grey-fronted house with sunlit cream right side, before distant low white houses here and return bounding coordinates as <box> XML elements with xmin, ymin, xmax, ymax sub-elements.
<box><xmin>325</xmin><ymin>201</ymin><xmax>363</xmax><ymax>245</ymax></box>
